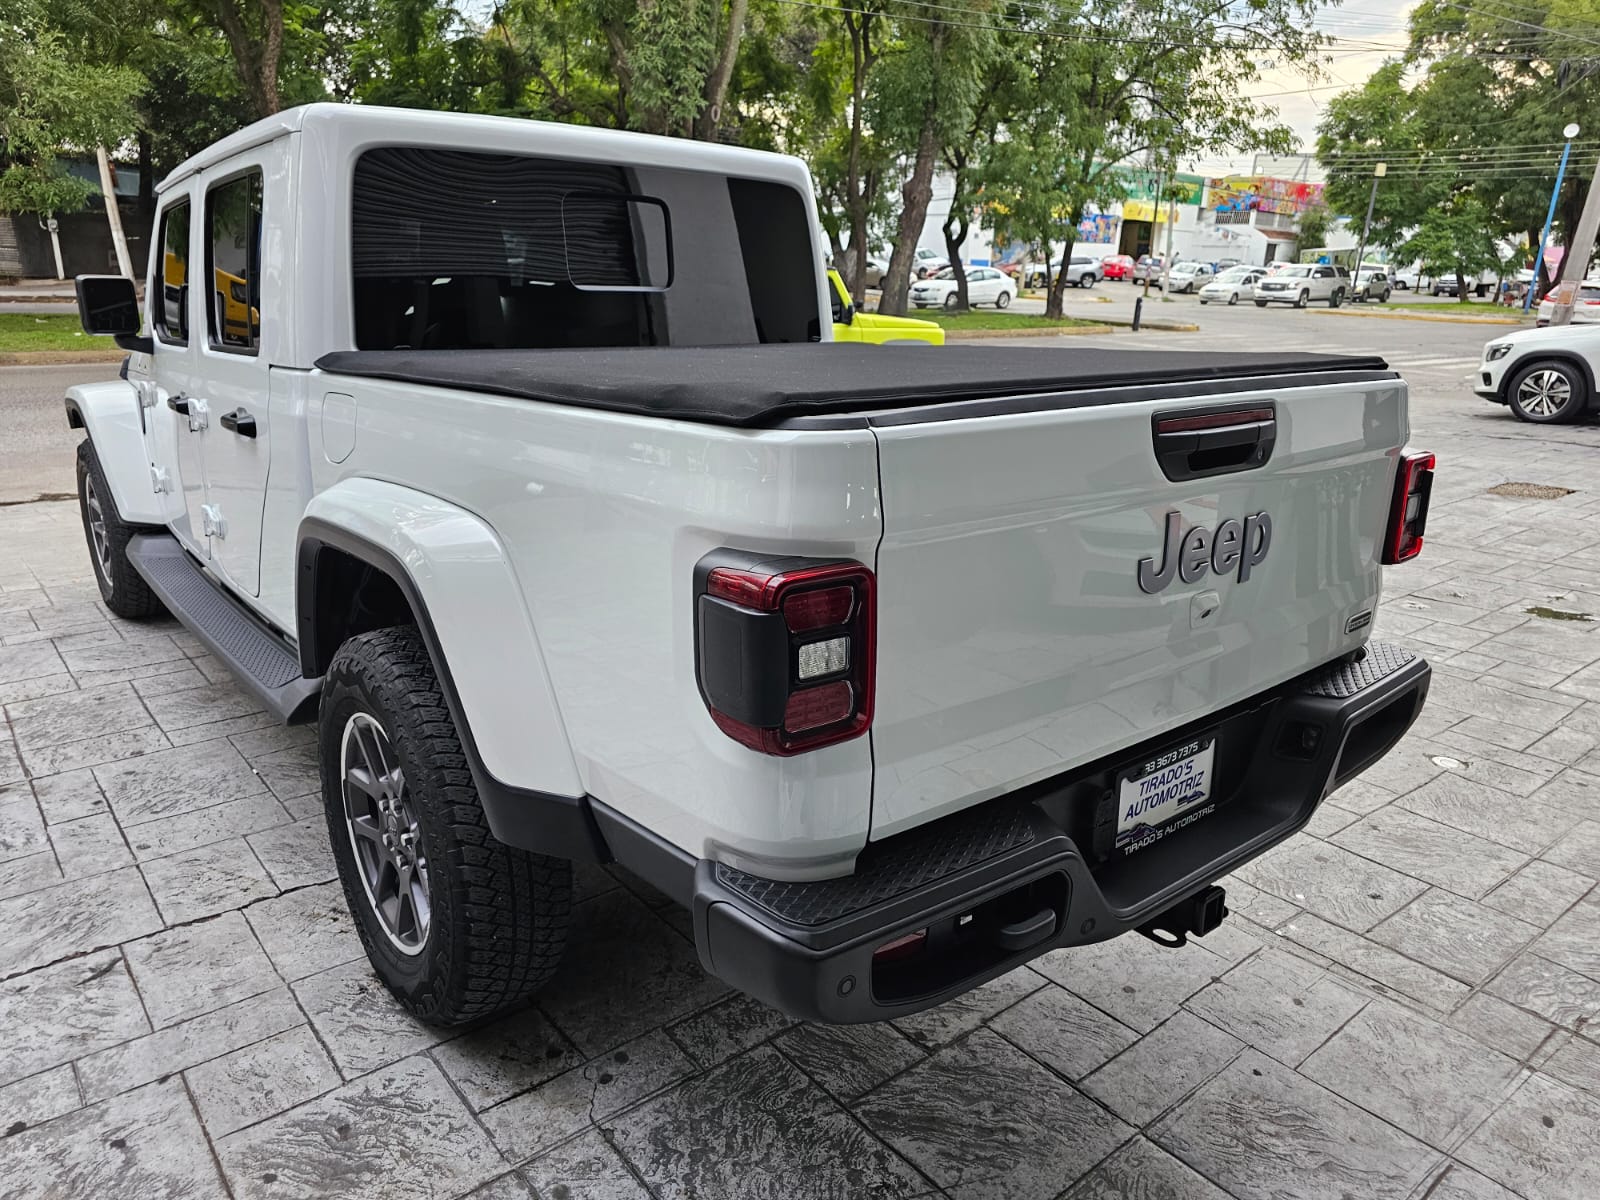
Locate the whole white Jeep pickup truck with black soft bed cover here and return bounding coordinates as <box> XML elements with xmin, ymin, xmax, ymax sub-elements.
<box><xmin>66</xmin><ymin>106</ymin><xmax>1434</xmax><ymax>1024</ymax></box>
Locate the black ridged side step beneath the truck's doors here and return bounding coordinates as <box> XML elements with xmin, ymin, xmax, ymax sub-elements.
<box><xmin>128</xmin><ymin>533</ymin><xmax>322</xmax><ymax>725</ymax></box>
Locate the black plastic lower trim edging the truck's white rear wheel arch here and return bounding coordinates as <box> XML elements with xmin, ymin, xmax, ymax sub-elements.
<box><xmin>296</xmin><ymin>517</ymin><xmax>611</xmax><ymax>862</ymax></box>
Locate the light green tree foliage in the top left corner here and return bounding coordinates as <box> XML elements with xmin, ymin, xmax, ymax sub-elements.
<box><xmin>0</xmin><ymin>0</ymin><xmax>144</xmax><ymax>214</ymax></box>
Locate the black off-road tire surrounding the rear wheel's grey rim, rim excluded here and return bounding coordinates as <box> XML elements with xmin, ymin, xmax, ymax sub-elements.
<box><xmin>318</xmin><ymin>626</ymin><xmax>573</xmax><ymax>1026</ymax></box>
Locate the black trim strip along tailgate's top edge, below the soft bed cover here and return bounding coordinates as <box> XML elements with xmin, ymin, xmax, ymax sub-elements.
<box><xmin>773</xmin><ymin>370</ymin><xmax>1402</xmax><ymax>429</ymax></box>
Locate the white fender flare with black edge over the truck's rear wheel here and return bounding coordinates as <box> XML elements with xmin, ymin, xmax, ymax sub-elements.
<box><xmin>296</xmin><ymin>478</ymin><xmax>605</xmax><ymax>861</ymax></box>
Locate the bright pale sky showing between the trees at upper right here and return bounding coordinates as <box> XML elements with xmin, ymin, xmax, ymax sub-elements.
<box><xmin>1186</xmin><ymin>0</ymin><xmax>1416</xmax><ymax>174</ymax></box>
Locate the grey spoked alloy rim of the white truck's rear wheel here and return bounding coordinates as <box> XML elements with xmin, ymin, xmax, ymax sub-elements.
<box><xmin>339</xmin><ymin>712</ymin><xmax>434</xmax><ymax>954</ymax></box>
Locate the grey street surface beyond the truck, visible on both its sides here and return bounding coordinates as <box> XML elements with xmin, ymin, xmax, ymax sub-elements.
<box><xmin>0</xmin><ymin>305</ymin><xmax>1510</xmax><ymax>504</ymax></box>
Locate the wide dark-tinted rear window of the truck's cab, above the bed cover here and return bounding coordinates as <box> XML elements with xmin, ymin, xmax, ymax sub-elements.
<box><xmin>350</xmin><ymin>146</ymin><xmax>821</xmax><ymax>350</ymax></box>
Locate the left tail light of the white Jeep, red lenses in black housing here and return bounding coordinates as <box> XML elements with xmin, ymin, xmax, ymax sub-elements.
<box><xmin>694</xmin><ymin>550</ymin><xmax>877</xmax><ymax>755</ymax></box>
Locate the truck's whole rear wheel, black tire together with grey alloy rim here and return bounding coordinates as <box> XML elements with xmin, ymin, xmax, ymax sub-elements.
<box><xmin>318</xmin><ymin>626</ymin><xmax>573</xmax><ymax>1026</ymax></box>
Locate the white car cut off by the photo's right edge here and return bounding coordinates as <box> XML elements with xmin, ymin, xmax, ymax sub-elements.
<box><xmin>1472</xmin><ymin>321</ymin><xmax>1600</xmax><ymax>426</ymax></box>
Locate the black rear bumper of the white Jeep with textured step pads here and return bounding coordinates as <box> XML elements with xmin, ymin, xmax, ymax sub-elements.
<box><xmin>636</xmin><ymin>643</ymin><xmax>1430</xmax><ymax>1022</ymax></box>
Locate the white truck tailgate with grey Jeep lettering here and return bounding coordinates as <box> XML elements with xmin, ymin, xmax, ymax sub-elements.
<box><xmin>872</xmin><ymin>379</ymin><xmax>1406</xmax><ymax>838</ymax></box>
